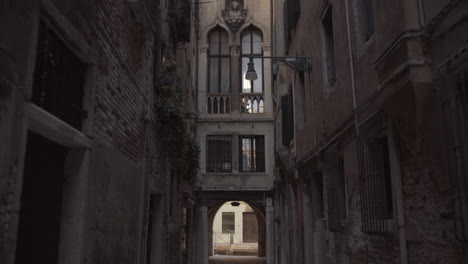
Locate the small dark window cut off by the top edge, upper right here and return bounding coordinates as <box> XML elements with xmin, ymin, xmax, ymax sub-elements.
<box><xmin>355</xmin><ymin>0</ymin><xmax>374</xmax><ymax>43</ymax></box>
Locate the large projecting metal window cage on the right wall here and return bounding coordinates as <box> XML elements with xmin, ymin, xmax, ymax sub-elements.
<box><xmin>359</xmin><ymin>111</ymin><xmax>393</xmax><ymax>234</ymax></box>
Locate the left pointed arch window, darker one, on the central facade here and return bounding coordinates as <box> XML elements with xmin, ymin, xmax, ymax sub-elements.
<box><xmin>208</xmin><ymin>26</ymin><xmax>231</xmax><ymax>93</ymax></box>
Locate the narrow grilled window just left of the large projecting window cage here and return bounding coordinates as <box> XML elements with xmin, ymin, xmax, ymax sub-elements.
<box><xmin>325</xmin><ymin>144</ymin><xmax>346</xmax><ymax>231</ymax></box>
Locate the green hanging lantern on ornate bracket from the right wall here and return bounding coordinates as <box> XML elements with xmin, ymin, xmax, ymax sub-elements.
<box><xmin>245</xmin><ymin>56</ymin><xmax>312</xmax><ymax>81</ymax></box>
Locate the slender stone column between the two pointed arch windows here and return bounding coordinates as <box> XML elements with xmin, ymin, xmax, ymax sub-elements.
<box><xmin>231</xmin><ymin>44</ymin><xmax>241</xmax><ymax>114</ymax></box>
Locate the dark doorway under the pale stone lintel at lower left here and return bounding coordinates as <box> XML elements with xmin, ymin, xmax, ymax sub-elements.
<box><xmin>15</xmin><ymin>132</ymin><xmax>67</xmax><ymax>264</ymax></box>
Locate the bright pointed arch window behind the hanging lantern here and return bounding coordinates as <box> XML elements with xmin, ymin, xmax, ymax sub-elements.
<box><xmin>241</xmin><ymin>26</ymin><xmax>263</xmax><ymax>93</ymax></box>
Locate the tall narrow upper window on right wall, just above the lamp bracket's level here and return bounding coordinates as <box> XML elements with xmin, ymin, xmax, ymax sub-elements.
<box><xmin>322</xmin><ymin>5</ymin><xmax>336</xmax><ymax>88</ymax></box>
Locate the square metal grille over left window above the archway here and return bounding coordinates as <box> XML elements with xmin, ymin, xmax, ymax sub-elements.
<box><xmin>206</xmin><ymin>135</ymin><xmax>232</xmax><ymax>172</ymax></box>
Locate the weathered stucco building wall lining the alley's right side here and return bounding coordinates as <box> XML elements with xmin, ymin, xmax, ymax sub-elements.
<box><xmin>273</xmin><ymin>0</ymin><xmax>468</xmax><ymax>263</ymax></box>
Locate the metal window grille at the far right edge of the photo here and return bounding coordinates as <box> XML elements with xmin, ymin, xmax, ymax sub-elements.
<box><xmin>442</xmin><ymin>65</ymin><xmax>468</xmax><ymax>241</ymax></box>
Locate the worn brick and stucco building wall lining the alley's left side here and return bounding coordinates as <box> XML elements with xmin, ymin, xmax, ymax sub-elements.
<box><xmin>0</xmin><ymin>0</ymin><xmax>194</xmax><ymax>264</ymax></box>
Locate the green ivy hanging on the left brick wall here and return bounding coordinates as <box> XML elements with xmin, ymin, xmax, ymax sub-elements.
<box><xmin>155</xmin><ymin>61</ymin><xmax>200</xmax><ymax>183</ymax></box>
